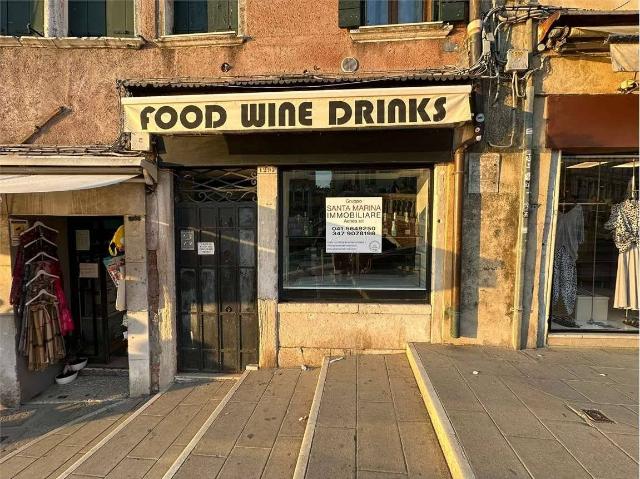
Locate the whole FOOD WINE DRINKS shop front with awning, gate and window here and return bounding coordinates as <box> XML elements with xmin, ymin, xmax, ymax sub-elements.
<box><xmin>122</xmin><ymin>82</ymin><xmax>473</xmax><ymax>372</ymax></box>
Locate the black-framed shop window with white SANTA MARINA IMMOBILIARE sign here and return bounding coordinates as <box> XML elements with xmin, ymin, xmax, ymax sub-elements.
<box><xmin>281</xmin><ymin>169</ymin><xmax>429</xmax><ymax>301</ymax></box>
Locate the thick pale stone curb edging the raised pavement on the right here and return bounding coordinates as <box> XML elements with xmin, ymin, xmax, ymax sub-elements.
<box><xmin>407</xmin><ymin>343</ymin><xmax>476</xmax><ymax>479</ymax></box>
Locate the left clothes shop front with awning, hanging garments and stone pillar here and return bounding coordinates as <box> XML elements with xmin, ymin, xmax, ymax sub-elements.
<box><xmin>0</xmin><ymin>152</ymin><xmax>155</xmax><ymax>406</ymax></box>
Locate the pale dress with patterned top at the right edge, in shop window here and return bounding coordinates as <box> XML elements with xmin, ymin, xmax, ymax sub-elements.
<box><xmin>604</xmin><ymin>199</ymin><xmax>640</xmax><ymax>310</ymax></box>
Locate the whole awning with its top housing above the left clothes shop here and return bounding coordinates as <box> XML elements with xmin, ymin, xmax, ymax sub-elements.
<box><xmin>0</xmin><ymin>150</ymin><xmax>157</xmax><ymax>193</ymax></box>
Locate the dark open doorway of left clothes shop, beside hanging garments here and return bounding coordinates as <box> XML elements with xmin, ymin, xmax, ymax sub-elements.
<box><xmin>68</xmin><ymin>216</ymin><xmax>128</xmax><ymax>369</ymax></box>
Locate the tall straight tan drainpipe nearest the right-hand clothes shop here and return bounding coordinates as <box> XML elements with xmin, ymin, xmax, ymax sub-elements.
<box><xmin>512</xmin><ymin>19</ymin><xmax>535</xmax><ymax>349</ymax></box>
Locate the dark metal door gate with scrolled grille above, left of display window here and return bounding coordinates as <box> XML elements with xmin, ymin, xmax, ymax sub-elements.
<box><xmin>175</xmin><ymin>169</ymin><xmax>258</xmax><ymax>372</ymax></box>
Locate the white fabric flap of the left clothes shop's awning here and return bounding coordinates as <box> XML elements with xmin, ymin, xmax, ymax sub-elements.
<box><xmin>0</xmin><ymin>174</ymin><xmax>138</xmax><ymax>193</ymax></box>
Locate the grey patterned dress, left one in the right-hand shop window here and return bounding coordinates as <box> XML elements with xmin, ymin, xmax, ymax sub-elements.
<box><xmin>551</xmin><ymin>205</ymin><xmax>584</xmax><ymax>315</ymax></box>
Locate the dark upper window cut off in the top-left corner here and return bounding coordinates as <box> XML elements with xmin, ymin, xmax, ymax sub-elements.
<box><xmin>0</xmin><ymin>0</ymin><xmax>44</xmax><ymax>36</ymax></box>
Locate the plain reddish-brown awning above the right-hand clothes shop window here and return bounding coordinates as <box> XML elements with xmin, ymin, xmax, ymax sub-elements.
<box><xmin>545</xmin><ymin>94</ymin><xmax>639</xmax><ymax>153</ymax></box>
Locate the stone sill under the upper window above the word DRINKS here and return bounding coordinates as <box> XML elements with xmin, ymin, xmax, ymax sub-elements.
<box><xmin>349</xmin><ymin>22</ymin><xmax>453</xmax><ymax>43</ymax></box>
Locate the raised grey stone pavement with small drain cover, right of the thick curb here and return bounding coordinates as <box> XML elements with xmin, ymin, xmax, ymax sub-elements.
<box><xmin>415</xmin><ymin>344</ymin><xmax>638</xmax><ymax>479</ymax></box>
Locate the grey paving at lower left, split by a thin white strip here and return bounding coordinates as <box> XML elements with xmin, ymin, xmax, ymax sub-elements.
<box><xmin>0</xmin><ymin>380</ymin><xmax>234</xmax><ymax>479</ymax></box>
